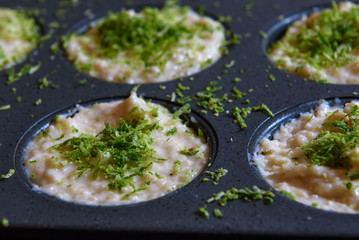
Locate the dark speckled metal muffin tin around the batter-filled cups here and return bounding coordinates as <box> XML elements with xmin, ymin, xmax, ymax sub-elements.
<box><xmin>0</xmin><ymin>0</ymin><xmax>359</xmax><ymax>238</ymax></box>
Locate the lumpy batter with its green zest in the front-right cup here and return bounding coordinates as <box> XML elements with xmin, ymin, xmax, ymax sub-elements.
<box><xmin>253</xmin><ymin>101</ymin><xmax>359</xmax><ymax>213</ymax></box>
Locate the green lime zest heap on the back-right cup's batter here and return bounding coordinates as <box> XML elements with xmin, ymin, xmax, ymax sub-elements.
<box><xmin>269</xmin><ymin>1</ymin><xmax>359</xmax><ymax>69</ymax></box>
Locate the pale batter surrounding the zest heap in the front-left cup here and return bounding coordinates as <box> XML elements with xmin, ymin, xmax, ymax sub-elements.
<box><xmin>25</xmin><ymin>94</ymin><xmax>209</xmax><ymax>205</ymax></box>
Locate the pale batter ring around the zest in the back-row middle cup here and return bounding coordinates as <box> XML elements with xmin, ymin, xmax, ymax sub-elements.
<box><xmin>65</xmin><ymin>3</ymin><xmax>225</xmax><ymax>84</ymax></box>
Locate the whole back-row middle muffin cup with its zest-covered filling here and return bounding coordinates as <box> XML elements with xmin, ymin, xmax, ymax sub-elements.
<box><xmin>62</xmin><ymin>1</ymin><xmax>229</xmax><ymax>84</ymax></box>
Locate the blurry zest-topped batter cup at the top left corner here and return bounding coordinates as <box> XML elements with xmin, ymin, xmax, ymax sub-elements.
<box><xmin>0</xmin><ymin>7</ymin><xmax>44</xmax><ymax>70</ymax></box>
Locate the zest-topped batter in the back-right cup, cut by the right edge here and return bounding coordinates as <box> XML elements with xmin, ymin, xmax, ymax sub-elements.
<box><xmin>268</xmin><ymin>2</ymin><xmax>359</xmax><ymax>84</ymax></box>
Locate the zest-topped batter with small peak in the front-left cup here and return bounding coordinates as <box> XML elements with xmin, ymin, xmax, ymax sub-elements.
<box><xmin>24</xmin><ymin>93</ymin><xmax>209</xmax><ymax>205</ymax></box>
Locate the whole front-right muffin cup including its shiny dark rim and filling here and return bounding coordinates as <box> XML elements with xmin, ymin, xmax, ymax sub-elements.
<box><xmin>248</xmin><ymin>97</ymin><xmax>359</xmax><ymax>213</ymax></box>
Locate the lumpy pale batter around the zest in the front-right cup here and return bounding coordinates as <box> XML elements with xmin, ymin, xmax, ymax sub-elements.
<box><xmin>253</xmin><ymin>101</ymin><xmax>359</xmax><ymax>213</ymax></box>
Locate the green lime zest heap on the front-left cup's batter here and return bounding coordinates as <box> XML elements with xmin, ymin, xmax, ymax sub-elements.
<box><xmin>52</xmin><ymin>108</ymin><xmax>159</xmax><ymax>192</ymax></box>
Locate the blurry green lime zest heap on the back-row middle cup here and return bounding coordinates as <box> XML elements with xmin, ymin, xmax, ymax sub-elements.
<box><xmin>98</xmin><ymin>1</ymin><xmax>222</xmax><ymax>67</ymax></box>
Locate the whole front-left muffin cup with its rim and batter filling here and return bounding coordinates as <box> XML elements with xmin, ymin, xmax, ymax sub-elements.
<box><xmin>15</xmin><ymin>94</ymin><xmax>218</xmax><ymax>206</ymax></box>
